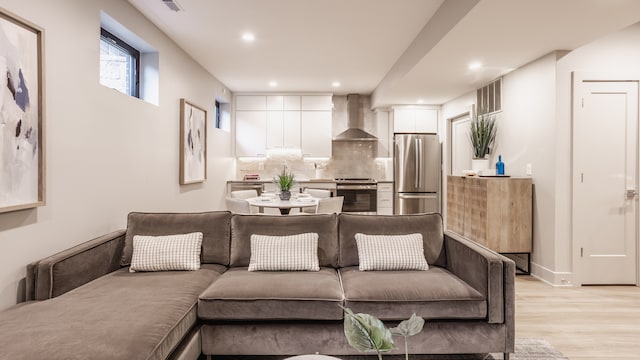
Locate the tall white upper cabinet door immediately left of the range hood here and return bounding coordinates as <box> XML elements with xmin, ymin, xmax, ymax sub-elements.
<box><xmin>300</xmin><ymin>111</ymin><xmax>332</xmax><ymax>157</ymax></box>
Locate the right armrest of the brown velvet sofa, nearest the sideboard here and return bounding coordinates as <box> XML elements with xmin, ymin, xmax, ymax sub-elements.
<box><xmin>444</xmin><ymin>231</ymin><xmax>515</xmax><ymax>324</ymax></box>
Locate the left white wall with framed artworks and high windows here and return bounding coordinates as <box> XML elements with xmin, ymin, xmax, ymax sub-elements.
<box><xmin>0</xmin><ymin>0</ymin><xmax>233</xmax><ymax>309</ymax></box>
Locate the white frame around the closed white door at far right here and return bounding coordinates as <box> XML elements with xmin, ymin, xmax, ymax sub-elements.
<box><xmin>571</xmin><ymin>71</ymin><xmax>640</xmax><ymax>286</ymax></box>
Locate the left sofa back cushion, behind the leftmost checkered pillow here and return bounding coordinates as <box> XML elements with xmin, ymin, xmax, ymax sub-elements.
<box><xmin>120</xmin><ymin>211</ymin><xmax>231</xmax><ymax>266</ymax></box>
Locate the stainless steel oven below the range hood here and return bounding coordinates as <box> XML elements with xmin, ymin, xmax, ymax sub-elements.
<box><xmin>336</xmin><ymin>178</ymin><xmax>378</xmax><ymax>215</ymax></box>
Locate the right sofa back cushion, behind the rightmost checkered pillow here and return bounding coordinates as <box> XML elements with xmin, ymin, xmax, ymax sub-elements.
<box><xmin>339</xmin><ymin>213</ymin><xmax>447</xmax><ymax>267</ymax></box>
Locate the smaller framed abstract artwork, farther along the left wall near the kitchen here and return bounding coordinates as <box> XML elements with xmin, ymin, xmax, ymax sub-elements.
<box><xmin>180</xmin><ymin>99</ymin><xmax>207</xmax><ymax>185</ymax></box>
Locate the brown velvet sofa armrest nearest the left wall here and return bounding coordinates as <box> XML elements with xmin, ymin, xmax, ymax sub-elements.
<box><xmin>33</xmin><ymin>230</ymin><xmax>125</xmax><ymax>300</ymax></box>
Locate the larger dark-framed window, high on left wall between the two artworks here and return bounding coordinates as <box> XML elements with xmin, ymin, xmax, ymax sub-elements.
<box><xmin>100</xmin><ymin>28</ymin><xmax>140</xmax><ymax>97</ymax></box>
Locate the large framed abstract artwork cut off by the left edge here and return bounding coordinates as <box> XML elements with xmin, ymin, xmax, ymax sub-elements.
<box><xmin>0</xmin><ymin>9</ymin><xmax>45</xmax><ymax>212</ymax></box>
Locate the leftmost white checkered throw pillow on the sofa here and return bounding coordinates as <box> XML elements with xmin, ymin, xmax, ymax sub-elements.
<box><xmin>129</xmin><ymin>232</ymin><xmax>202</xmax><ymax>272</ymax></box>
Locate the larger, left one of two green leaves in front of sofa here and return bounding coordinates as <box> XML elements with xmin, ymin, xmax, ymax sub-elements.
<box><xmin>343</xmin><ymin>308</ymin><xmax>395</xmax><ymax>353</ymax></box>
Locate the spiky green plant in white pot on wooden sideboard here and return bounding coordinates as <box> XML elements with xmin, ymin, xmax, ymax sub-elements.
<box><xmin>469</xmin><ymin>114</ymin><xmax>498</xmax><ymax>174</ymax></box>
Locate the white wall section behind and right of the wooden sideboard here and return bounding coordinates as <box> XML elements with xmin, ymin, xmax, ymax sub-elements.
<box><xmin>500</xmin><ymin>53</ymin><xmax>557</xmax><ymax>274</ymax></box>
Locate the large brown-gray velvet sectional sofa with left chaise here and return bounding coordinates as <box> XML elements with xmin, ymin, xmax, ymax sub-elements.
<box><xmin>0</xmin><ymin>212</ymin><xmax>515</xmax><ymax>360</ymax></box>
